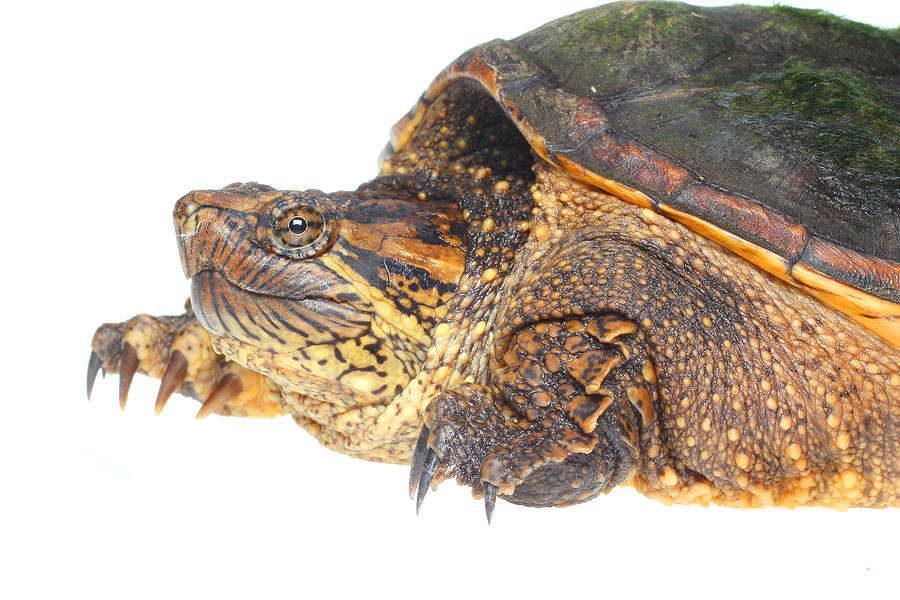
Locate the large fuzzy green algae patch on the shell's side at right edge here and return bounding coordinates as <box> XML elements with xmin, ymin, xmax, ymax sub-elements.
<box><xmin>713</xmin><ymin>62</ymin><xmax>900</xmax><ymax>185</ymax></box>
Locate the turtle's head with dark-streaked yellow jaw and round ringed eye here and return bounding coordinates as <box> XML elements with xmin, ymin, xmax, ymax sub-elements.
<box><xmin>174</xmin><ymin>184</ymin><xmax>465</xmax><ymax>404</ymax></box>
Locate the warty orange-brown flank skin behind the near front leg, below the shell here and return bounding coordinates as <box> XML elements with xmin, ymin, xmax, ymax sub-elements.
<box><xmin>510</xmin><ymin>169</ymin><xmax>900</xmax><ymax>508</ymax></box>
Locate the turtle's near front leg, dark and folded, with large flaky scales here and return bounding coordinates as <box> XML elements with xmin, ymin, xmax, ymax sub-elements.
<box><xmin>410</xmin><ymin>314</ymin><xmax>656</xmax><ymax>520</ymax></box>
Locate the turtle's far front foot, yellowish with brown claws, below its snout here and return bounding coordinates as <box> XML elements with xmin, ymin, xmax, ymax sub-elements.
<box><xmin>87</xmin><ymin>306</ymin><xmax>284</xmax><ymax>418</ymax></box>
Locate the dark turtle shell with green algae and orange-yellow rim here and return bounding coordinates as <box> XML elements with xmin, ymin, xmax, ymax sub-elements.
<box><xmin>391</xmin><ymin>2</ymin><xmax>900</xmax><ymax>346</ymax></box>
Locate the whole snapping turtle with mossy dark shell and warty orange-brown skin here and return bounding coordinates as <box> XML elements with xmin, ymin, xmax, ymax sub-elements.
<box><xmin>87</xmin><ymin>2</ymin><xmax>900</xmax><ymax>519</ymax></box>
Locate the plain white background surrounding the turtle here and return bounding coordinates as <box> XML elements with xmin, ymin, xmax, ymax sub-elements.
<box><xmin>0</xmin><ymin>0</ymin><xmax>900</xmax><ymax>598</ymax></box>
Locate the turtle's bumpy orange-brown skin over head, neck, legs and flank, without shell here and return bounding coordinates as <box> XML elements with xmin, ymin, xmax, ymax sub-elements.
<box><xmin>92</xmin><ymin>64</ymin><xmax>900</xmax><ymax>518</ymax></box>
